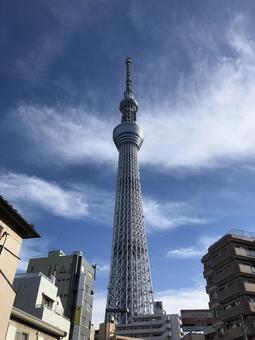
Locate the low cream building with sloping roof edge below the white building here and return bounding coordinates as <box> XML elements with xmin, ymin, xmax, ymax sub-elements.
<box><xmin>6</xmin><ymin>307</ymin><xmax>66</xmax><ymax>340</ymax></box>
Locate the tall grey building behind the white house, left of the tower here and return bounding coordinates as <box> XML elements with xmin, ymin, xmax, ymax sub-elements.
<box><xmin>27</xmin><ymin>250</ymin><xmax>95</xmax><ymax>340</ymax></box>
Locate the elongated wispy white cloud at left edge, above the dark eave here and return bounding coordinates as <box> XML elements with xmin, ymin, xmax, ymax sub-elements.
<box><xmin>0</xmin><ymin>172</ymin><xmax>88</xmax><ymax>219</ymax></box>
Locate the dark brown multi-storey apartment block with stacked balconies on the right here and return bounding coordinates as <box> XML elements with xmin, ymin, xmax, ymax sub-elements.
<box><xmin>202</xmin><ymin>231</ymin><xmax>255</xmax><ymax>340</ymax></box>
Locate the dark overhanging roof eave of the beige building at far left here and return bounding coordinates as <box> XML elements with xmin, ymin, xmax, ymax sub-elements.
<box><xmin>0</xmin><ymin>195</ymin><xmax>40</xmax><ymax>239</ymax></box>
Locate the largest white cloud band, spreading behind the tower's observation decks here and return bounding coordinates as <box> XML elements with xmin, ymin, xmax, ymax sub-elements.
<box><xmin>11</xmin><ymin>19</ymin><xmax>255</xmax><ymax>169</ymax></box>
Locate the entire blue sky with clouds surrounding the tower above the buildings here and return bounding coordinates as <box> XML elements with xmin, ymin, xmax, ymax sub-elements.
<box><xmin>0</xmin><ymin>0</ymin><xmax>255</xmax><ymax>323</ymax></box>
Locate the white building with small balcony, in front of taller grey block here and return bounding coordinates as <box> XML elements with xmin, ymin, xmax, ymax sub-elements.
<box><xmin>13</xmin><ymin>273</ymin><xmax>70</xmax><ymax>340</ymax></box>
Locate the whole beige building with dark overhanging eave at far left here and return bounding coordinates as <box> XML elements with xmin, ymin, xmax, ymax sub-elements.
<box><xmin>0</xmin><ymin>196</ymin><xmax>40</xmax><ymax>339</ymax></box>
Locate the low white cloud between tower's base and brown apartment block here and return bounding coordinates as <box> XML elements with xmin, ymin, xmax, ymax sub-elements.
<box><xmin>155</xmin><ymin>286</ymin><xmax>209</xmax><ymax>314</ymax></box>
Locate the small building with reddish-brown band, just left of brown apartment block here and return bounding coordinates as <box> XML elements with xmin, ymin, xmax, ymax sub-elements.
<box><xmin>181</xmin><ymin>309</ymin><xmax>213</xmax><ymax>333</ymax></box>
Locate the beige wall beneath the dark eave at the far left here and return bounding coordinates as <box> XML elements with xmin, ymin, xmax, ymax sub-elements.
<box><xmin>0</xmin><ymin>220</ymin><xmax>22</xmax><ymax>339</ymax></box>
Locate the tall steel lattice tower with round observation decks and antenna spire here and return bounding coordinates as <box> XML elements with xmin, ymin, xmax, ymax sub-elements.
<box><xmin>106</xmin><ymin>58</ymin><xmax>153</xmax><ymax>324</ymax></box>
